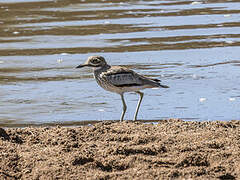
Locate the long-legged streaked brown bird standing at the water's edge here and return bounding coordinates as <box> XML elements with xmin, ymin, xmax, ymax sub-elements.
<box><xmin>76</xmin><ymin>56</ymin><xmax>169</xmax><ymax>121</ymax></box>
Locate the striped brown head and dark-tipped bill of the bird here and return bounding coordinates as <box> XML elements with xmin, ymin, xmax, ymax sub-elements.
<box><xmin>76</xmin><ymin>56</ymin><xmax>107</xmax><ymax>68</ymax></box>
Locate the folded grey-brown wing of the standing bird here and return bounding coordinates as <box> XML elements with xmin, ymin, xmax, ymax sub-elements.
<box><xmin>101</xmin><ymin>66</ymin><xmax>142</xmax><ymax>87</ymax></box>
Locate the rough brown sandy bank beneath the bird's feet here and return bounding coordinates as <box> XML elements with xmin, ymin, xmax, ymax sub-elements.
<box><xmin>0</xmin><ymin>119</ymin><xmax>240</xmax><ymax>179</ymax></box>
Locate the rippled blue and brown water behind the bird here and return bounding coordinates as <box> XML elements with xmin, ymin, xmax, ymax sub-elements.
<box><xmin>0</xmin><ymin>0</ymin><xmax>240</xmax><ymax>126</ymax></box>
